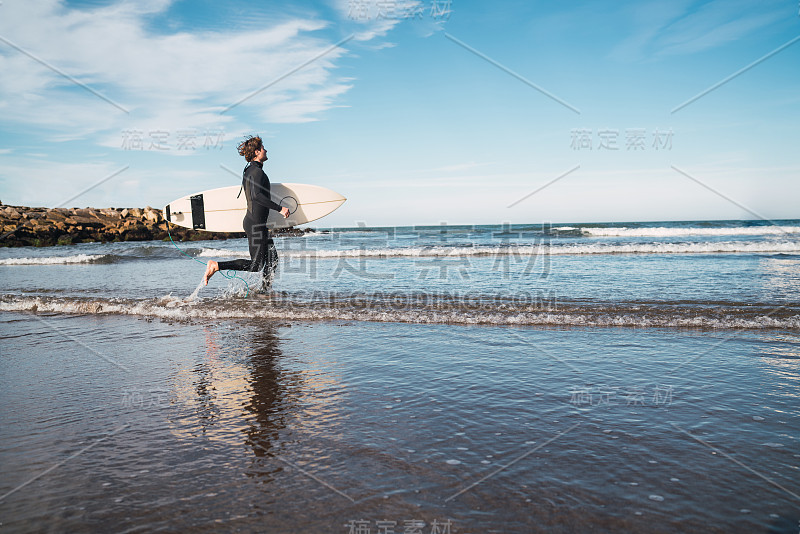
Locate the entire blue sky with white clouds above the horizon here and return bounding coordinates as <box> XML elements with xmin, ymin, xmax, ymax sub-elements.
<box><xmin>0</xmin><ymin>0</ymin><xmax>800</xmax><ymax>227</ymax></box>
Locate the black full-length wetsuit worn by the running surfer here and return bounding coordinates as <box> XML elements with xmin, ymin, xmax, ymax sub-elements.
<box><xmin>219</xmin><ymin>161</ymin><xmax>281</xmax><ymax>287</ymax></box>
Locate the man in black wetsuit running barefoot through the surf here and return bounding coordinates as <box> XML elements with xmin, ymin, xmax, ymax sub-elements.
<box><xmin>203</xmin><ymin>137</ymin><xmax>289</xmax><ymax>289</ymax></box>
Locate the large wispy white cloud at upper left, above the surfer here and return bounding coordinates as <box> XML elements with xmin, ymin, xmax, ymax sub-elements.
<box><xmin>0</xmin><ymin>0</ymin><xmax>360</xmax><ymax>147</ymax></box>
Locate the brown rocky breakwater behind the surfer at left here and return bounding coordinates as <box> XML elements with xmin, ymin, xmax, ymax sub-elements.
<box><xmin>0</xmin><ymin>203</ymin><xmax>311</xmax><ymax>247</ymax></box>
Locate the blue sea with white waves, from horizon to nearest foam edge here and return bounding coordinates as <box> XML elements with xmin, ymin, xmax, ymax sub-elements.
<box><xmin>0</xmin><ymin>221</ymin><xmax>800</xmax><ymax>331</ymax></box>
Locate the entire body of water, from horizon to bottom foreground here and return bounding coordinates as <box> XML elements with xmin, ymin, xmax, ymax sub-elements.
<box><xmin>0</xmin><ymin>220</ymin><xmax>800</xmax><ymax>534</ymax></box>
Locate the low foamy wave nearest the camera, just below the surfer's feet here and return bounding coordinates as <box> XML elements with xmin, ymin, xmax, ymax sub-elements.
<box><xmin>0</xmin><ymin>292</ymin><xmax>800</xmax><ymax>331</ymax></box>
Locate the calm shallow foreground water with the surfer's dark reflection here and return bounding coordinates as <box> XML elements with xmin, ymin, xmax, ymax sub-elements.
<box><xmin>0</xmin><ymin>313</ymin><xmax>800</xmax><ymax>532</ymax></box>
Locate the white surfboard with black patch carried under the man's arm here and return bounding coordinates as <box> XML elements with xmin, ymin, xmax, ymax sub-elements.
<box><xmin>164</xmin><ymin>183</ymin><xmax>347</xmax><ymax>232</ymax></box>
